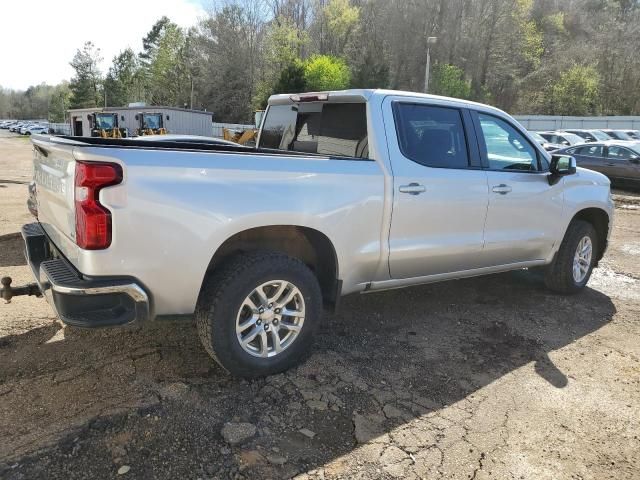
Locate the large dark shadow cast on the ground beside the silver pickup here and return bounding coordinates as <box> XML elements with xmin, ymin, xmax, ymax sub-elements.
<box><xmin>0</xmin><ymin>272</ymin><xmax>616</xmax><ymax>478</ymax></box>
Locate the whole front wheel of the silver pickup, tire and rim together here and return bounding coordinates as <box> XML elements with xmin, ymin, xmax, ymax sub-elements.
<box><xmin>545</xmin><ymin>220</ymin><xmax>598</xmax><ymax>294</ymax></box>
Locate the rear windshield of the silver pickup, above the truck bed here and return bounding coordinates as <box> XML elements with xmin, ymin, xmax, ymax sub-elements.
<box><xmin>260</xmin><ymin>102</ymin><xmax>369</xmax><ymax>158</ymax></box>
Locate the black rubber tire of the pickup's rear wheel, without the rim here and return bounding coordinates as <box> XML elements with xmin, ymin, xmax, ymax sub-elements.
<box><xmin>195</xmin><ymin>252</ymin><xmax>322</xmax><ymax>378</ymax></box>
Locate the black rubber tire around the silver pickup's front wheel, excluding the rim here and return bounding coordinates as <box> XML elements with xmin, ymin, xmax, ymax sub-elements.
<box><xmin>544</xmin><ymin>220</ymin><xmax>599</xmax><ymax>294</ymax></box>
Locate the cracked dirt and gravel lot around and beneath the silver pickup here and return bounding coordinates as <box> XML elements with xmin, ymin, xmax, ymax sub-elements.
<box><xmin>0</xmin><ymin>131</ymin><xmax>640</xmax><ymax>480</ymax></box>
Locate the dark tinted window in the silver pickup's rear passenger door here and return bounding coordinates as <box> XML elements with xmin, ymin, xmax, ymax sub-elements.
<box><xmin>394</xmin><ymin>103</ymin><xmax>469</xmax><ymax>168</ymax></box>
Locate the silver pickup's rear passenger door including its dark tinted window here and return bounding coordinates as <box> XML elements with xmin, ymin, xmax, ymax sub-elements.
<box><xmin>383</xmin><ymin>97</ymin><xmax>488</xmax><ymax>279</ymax></box>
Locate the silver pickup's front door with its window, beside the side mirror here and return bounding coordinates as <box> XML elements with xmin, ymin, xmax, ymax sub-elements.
<box><xmin>473</xmin><ymin>112</ymin><xmax>563</xmax><ymax>266</ymax></box>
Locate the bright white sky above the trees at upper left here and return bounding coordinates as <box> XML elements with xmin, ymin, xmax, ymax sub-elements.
<box><xmin>0</xmin><ymin>0</ymin><xmax>208</xmax><ymax>90</ymax></box>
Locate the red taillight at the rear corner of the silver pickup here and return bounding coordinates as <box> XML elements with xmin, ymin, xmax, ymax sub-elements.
<box><xmin>75</xmin><ymin>162</ymin><xmax>122</xmax><ymax>250</ymax></box>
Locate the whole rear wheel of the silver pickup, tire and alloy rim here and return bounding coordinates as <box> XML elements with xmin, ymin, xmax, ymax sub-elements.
<box><xmin>195</xmin><ymin>253</ymin><xmax>322</xmax><ymax>378</ymax></box>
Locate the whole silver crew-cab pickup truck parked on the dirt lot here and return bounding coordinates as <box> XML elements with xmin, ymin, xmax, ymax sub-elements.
<box><xmin>2</xmin><ymin>90</ymin><xmax>613</xmax><ymax>377</ymax></box>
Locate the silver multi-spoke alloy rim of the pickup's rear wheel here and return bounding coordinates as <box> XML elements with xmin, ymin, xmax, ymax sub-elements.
<box><xmin>236</xmin><ymin>280</ymin><xmax>305</xmax><ymax>358</ymax></box>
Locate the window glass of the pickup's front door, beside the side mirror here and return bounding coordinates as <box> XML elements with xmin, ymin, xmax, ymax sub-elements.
<box><xmin>478</xmin><ymin>113</ymin><xmax>539</xmax><ymax>171</ymax></box>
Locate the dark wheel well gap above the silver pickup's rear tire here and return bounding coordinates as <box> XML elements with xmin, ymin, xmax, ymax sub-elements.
<box><xmin>201</xmin><ymin>225</ymin><xmax>342</xmax><ymax>308</ymax></box>
